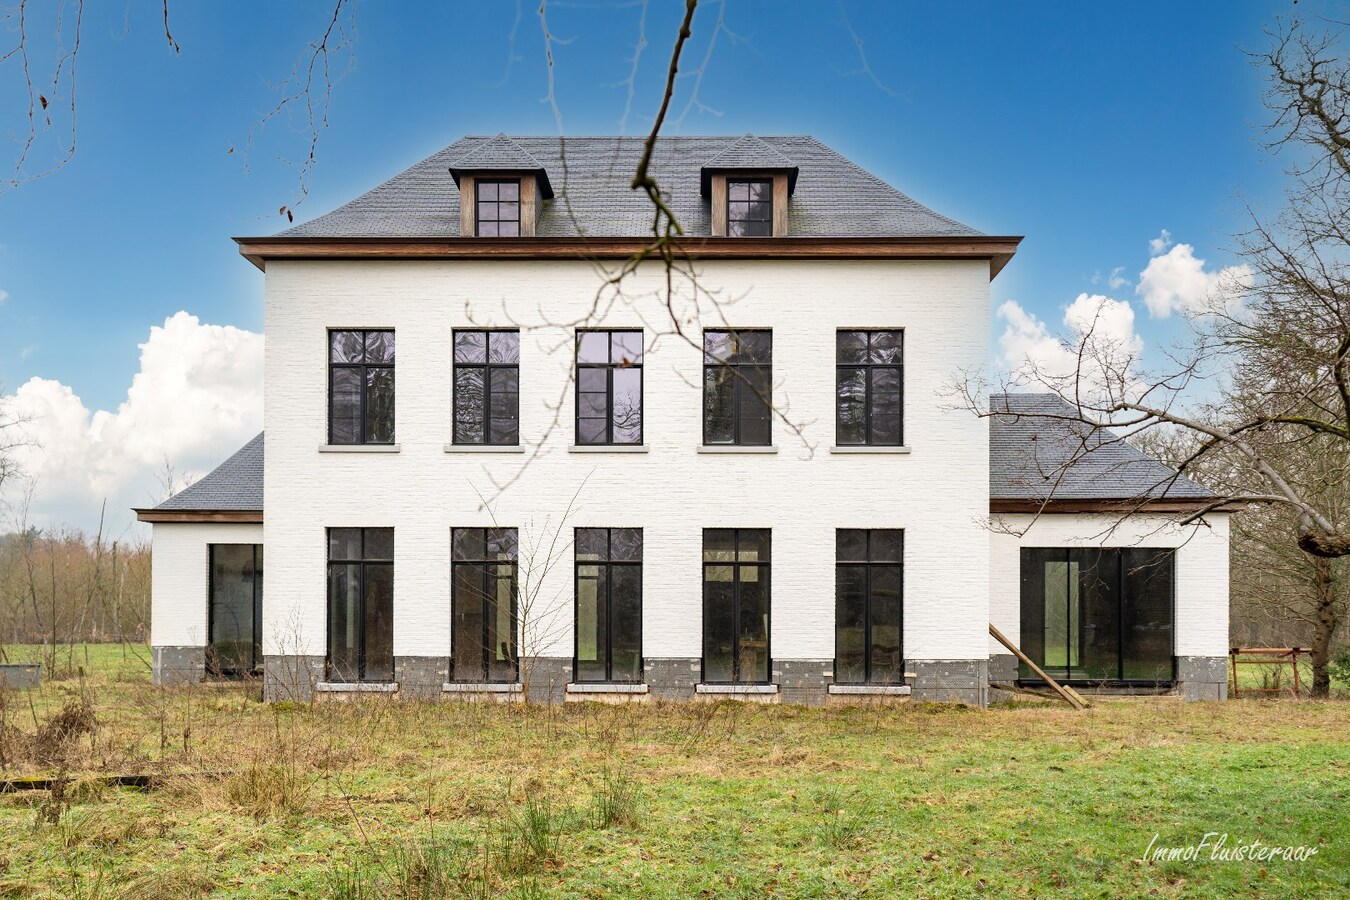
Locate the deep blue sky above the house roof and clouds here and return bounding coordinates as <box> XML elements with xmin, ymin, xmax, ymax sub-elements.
<box><xmin>0</xmin><ymin>0</ymin><xmax>1317</xmax><ymax>531</ymax></box>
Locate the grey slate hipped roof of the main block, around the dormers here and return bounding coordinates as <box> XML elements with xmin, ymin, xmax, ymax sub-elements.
<box><xmin>281</xmin><ymin>135</ymin><xmax>980</xmax><ymax>239</ymax></box>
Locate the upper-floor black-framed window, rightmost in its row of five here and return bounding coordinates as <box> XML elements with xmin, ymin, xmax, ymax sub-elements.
<box><xmin>834</xmin><ymin>328</ymin><xmax>905</xmax><ymax>447</ymax></box>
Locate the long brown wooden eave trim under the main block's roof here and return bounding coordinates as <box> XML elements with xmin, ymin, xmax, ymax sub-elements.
<box><xmin>235</xmin><ymin>235</ymin><xmax>1022</xmax><ymax>281</ymax></box>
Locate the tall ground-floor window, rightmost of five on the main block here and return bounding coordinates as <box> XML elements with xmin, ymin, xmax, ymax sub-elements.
<box><xmin>834</xmin><ymin>528</ymin><xmax>905</xmax><ymax>684</ymax></box>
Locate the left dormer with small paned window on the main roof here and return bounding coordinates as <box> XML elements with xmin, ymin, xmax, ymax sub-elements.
<box><xmin>450</xmin><ymin>134</ymin><xmax>554</xmax><ymax>237</ymax></box>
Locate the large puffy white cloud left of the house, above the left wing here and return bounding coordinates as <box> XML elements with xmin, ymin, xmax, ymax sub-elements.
<box><xmin>4</xmin><ymin>312</ymin><xmax>263</xmax><ymax>528</ymax></box>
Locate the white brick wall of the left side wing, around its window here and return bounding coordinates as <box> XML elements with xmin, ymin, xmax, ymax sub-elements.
<box><xmin>150</xmin><ymin>522</ymin><xmax>266</xmax><ymax>646</ymax></box>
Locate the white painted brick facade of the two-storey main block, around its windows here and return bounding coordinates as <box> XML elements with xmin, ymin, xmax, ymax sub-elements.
<box><xmin>263</xmin><ymin>260</ymin><xmax>988</xmax><ymax>658</ymax></box>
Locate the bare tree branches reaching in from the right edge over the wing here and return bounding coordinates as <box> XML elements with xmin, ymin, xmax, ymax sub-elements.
<box><xmin>957</xmin><ymin>22</ymin><xmax>1350</xmax><ymax>559</ymax></box>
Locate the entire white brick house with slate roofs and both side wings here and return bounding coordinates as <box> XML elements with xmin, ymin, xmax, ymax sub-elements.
<box><xmin>139</xmin><ymin>135</ymin><xmax>1227</xmax><ymax>704</ymax></box>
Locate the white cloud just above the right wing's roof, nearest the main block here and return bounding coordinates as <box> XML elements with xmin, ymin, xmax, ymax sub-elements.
<box><xmin>998</xmin><ymin>293</ymin><xmax>1143</xmax><ymax>399</ymax></box>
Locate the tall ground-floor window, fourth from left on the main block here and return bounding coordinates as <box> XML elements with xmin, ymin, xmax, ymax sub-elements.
<box><xmin>703</xmin><ymin>528</ymin><xmax>770</xmax><ymax>684</ymax></box>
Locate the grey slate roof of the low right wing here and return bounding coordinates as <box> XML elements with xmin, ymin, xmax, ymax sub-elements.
<box><xmin>990</xmin><ymin>394</ymin><xmax>1214</xmax><ymax>501</ymax></box>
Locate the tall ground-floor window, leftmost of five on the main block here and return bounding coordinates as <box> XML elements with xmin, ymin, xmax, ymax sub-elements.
<box><xmin>328</xmin><ymin>528</ymin><xmax>394</xmax><ymax>681</ymax></box>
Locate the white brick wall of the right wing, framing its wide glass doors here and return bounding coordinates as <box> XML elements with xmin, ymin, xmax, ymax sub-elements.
<box><xmin>990</xmin><ymin>513</ymin><xmax>1229</xmax><ymax>656</ymax></box>
